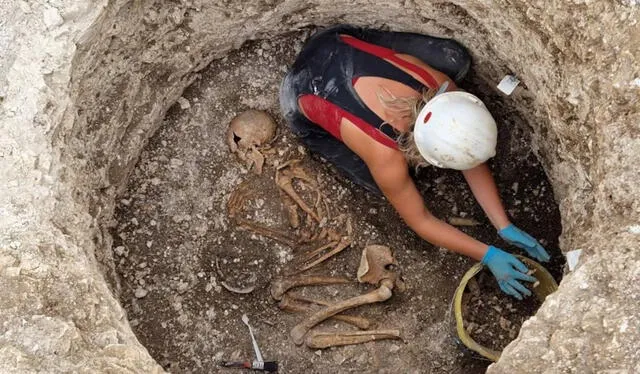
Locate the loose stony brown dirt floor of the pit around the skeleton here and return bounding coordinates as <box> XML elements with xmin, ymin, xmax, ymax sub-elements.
<box><xmin>112</xmin><ymin>30</ymin><xmax>562</xmax><ymax>373</ymax></box>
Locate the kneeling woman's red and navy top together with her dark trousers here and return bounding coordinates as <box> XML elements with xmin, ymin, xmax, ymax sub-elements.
<box><xmin>280</xmin><ymin>25</ymin><xmax>471</xmax><ymax>194</ymax></box>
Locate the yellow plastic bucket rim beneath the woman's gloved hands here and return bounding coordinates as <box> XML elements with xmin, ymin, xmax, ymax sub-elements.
<box><xmin>453</xmin><ymin>255</ymin><xmax>558</xmax><ymax>362</ymax></box>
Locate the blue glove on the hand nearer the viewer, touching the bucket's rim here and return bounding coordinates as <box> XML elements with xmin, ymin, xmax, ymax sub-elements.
<box><xmin>482</xmin><ymin>246</ymin><xmax>537</xmax><ymax>300</ymax></box>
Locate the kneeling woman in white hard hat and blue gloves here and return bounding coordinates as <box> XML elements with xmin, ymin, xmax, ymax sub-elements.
<box><xmin>280</xmin><ymin>25</ymin><xmax>549</xmax><ymax>299</ymax></box>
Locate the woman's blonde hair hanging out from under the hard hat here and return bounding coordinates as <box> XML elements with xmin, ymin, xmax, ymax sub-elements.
<box><xmin>376</xmin><ymin>87</ymin><xmax>436</xmax><ymax>170</ymax></box>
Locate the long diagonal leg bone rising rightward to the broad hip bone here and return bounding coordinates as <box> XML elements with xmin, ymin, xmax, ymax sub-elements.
<box><xmin>291</xmin><ymin>279</ymin><xmax>394</xmax><ymax>345</ymax></box>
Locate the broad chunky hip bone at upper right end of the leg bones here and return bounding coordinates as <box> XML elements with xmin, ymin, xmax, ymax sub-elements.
<box><xmin>358</xmin><ymin>245</ymin><xmax>404</xmax><ymax>291</ymax></box>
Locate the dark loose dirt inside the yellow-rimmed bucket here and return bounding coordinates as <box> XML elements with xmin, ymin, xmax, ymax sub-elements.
<box><xmin>462</xmin><ymin>270</ymin><xmax>541</xmax><ymax>351</ymax></box>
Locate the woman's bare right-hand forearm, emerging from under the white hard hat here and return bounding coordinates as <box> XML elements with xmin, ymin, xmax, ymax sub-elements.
<box><xmin>462</xmin><ymin>164</ymin><xmax>511</xmax><ymax>230</ymax></box>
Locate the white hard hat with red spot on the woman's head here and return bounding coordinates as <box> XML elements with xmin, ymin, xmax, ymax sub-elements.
<box><xmin>413</xmin><ymin>91</ymin><xmax>498</xmax><ymax>170</ymax></box>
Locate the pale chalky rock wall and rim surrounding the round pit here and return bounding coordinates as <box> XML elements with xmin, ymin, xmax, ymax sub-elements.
<box><xmin>0</xmin><ymin>0</ymin><xmax>640</xmax><ymax>372</ymax></box>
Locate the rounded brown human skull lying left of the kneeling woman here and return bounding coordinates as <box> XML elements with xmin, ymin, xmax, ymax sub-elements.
<box><xmin>227</xmin><ymin>109</ymin><xmax>276</xmax><ymax>153</ymax></box>
